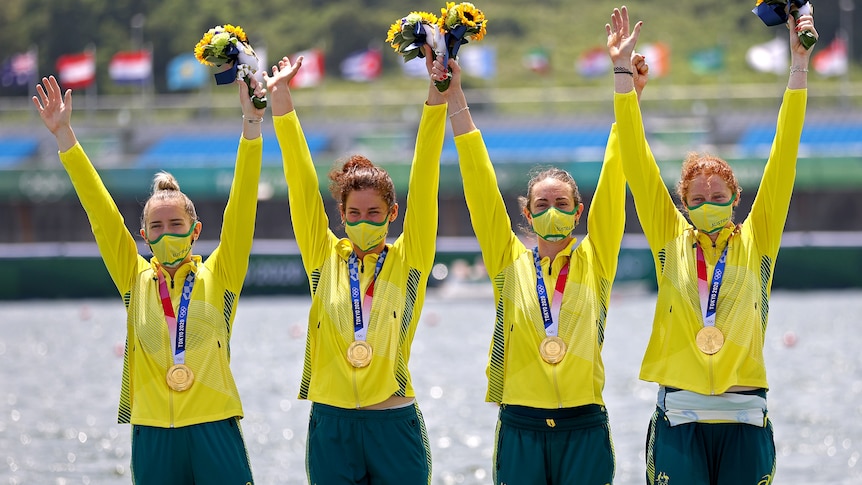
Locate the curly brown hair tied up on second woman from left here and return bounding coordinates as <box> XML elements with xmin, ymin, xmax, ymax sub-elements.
<box><xmin>329</xmin><ymin>155</ymin><xmax>396</xmax><ymax>209</ymax></box>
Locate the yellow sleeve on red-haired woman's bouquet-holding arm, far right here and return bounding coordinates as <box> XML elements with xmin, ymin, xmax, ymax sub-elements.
<box><xmin>747</xmin><ymin>89</ymin><xmax>808</xmax><ymax>256</ymax></box>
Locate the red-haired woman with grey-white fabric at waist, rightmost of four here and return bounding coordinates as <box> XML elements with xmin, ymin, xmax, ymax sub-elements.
<box><xmin>607</xmin><ymin>7</ymin><xmax>817</xmax><ymax>485</ymax></box>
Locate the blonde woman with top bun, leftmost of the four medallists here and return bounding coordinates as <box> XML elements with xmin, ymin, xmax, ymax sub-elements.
<box><xmin>33</xmin><ymin>76</ymin><xmax>264</xmax><ymax>485</ymax></box>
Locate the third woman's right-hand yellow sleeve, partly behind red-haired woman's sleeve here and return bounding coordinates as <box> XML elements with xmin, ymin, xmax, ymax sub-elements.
<box><xmin>587</xmin><ymin>124</ymin><xmax>626</xmax><ymax>279</ymax></box>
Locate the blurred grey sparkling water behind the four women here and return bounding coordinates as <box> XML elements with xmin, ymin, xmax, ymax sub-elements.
<box><xmin>0</xmin><ymin>286</ymin><xmax>862</xmax><ymax>485</ymax></box>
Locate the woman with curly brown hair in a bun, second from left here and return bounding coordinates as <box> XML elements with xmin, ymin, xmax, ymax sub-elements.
<box><xmin>268</xmin><ymin>46</ymin><xmax>446</xmax><ymax>484</ymax></box>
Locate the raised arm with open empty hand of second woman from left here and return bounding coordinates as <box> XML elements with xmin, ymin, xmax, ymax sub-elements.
<box><xmin>264</xmin><ymin>56</ymin><xmax>335</xmax><ymax>275</ymax></box>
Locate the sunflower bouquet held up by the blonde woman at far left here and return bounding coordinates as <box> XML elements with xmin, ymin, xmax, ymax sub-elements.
<box><xmin>195</xmin><ymin>24</ymin><xmax>266</xmax><ymax>108</ymax></box>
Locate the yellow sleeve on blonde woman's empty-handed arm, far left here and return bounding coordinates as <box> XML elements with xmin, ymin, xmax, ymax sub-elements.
<box><xmin>60</xmin><ymin>143</ymin><xmax>148</xmax><ymax>295</ymax></box>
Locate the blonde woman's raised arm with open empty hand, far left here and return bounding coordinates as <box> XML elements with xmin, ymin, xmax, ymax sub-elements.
<box><xmin>33</xmin><ymin>76</ymin><xmax>146</xmax><ymax>295</ymax></box>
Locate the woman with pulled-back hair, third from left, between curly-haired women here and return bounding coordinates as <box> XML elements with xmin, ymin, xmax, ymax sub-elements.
<box><xmin>432</xmin><ymin>42</ymin><xmax>648</xmax><ymax>485</ymax></box>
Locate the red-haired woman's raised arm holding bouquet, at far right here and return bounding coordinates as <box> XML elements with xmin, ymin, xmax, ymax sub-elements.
<box><xmin>748</xmin><ymin>11</ymin><xmax>818</xmax><ymax>255</ymax></box>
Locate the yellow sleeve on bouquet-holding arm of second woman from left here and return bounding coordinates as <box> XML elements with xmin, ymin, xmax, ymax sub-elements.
<box><xmin>404</xmin><ymin>104</ymin><xmax>447</xmax><ymax>270</ymax></box>
